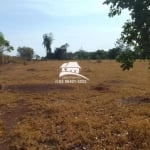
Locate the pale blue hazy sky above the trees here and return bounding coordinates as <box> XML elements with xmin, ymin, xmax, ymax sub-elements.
<box><xmin>0</xmin><ymin>0</ymin><xmax>129</xmax><ymax>56</ymax></box>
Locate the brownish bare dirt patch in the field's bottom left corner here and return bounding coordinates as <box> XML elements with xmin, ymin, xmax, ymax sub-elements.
<box><xmin>0</xmin><ymin>101</ymin><xmax>29</xmax><ymax>150</ymax></box>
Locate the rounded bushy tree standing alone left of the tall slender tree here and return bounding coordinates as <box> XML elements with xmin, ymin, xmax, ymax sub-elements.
<box><xmin>17</xmin><ymin>47</ymin><xmax>34</xmax><ymax>60</ymax></box>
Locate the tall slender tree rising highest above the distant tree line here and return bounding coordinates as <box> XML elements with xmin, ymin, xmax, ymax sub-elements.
<box><xmin>43</xmin><ymin>33</ymin><xmax>54</xmax><ymax>58</ymax></box>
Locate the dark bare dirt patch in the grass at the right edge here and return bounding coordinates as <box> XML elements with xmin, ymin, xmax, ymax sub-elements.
<box><xmin>122</xmin><ymin>96</ymin><xmax>150</xmax><ymax>105</ymax></box>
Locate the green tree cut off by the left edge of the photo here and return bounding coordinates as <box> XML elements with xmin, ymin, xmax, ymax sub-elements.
<box><xmin>0</xmin><ymin>32</ymin><xmax>14</xmax><ymax>55</ymax></box>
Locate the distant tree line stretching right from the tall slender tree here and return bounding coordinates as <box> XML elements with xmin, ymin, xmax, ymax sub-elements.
<box><xmin>43</xmin><ymin>33</ymin><xmax>145</xmax><ymax>63</ymax></box>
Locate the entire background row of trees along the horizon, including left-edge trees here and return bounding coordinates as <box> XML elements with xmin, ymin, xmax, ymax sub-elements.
<box><xmin>0</xmin><ymin>30</ymin><xmax>149</xmax><ymax>68</ymax></box>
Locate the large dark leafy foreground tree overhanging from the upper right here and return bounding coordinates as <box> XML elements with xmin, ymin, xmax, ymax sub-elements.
<box><xmin>104</xmin><ymin>0</ymin><xmax>150</xmax><ymax>69</ymax></box>
